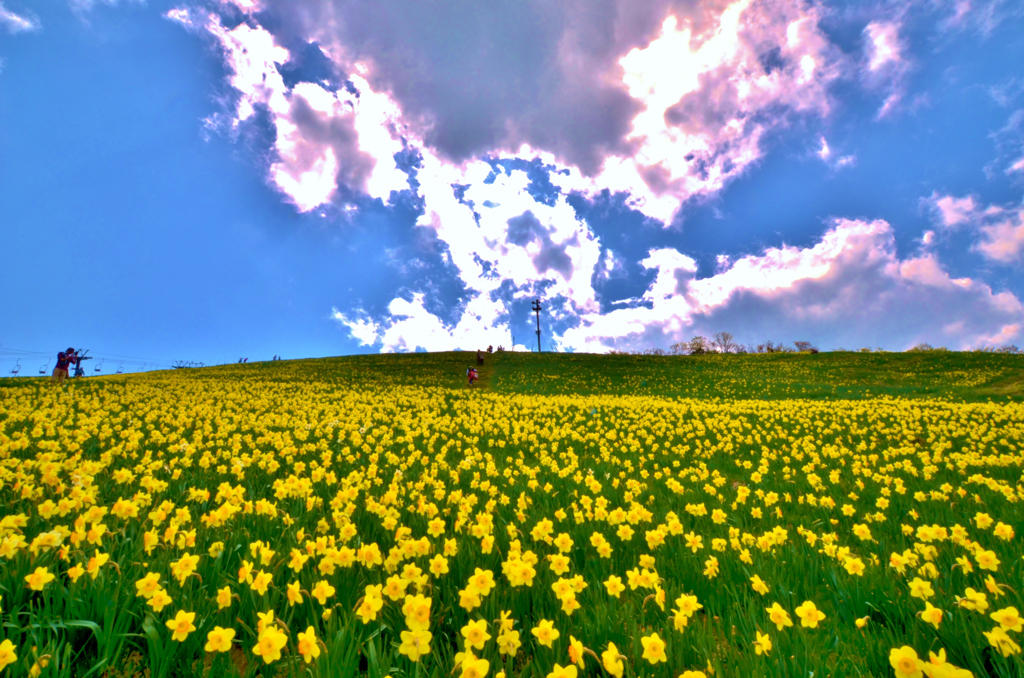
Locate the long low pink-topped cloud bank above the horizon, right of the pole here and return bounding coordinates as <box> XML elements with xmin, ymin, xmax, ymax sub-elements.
<box><xmin>563</xmin><ymin>219</ymin><xmax>1024</xmax><ymax>351</ymax></box>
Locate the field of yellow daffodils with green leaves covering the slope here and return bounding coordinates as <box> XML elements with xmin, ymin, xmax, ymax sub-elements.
<box><xmin>0</xmin><ymin>354</ymin><xmax>1024</xmax><ymax>678</ymax></box>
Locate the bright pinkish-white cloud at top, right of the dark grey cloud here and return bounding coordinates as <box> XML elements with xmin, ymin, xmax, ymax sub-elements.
<box><xmin>577</xmin><ymin>0</ymin><xmax>842</xmax><ymax>222</ymax></box>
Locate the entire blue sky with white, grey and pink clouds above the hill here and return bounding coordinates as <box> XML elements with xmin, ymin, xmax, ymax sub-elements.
<box><xmin>0</xmin><ymin>0</ymin><xmax>1024</xmax><ymax>373</ymax></box>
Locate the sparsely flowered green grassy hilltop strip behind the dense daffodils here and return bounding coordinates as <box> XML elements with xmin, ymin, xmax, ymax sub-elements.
<box><xmin>22</xmin><ymin>351</ymin><xmax>1024</xmax><ymax>401</ymax></box>
